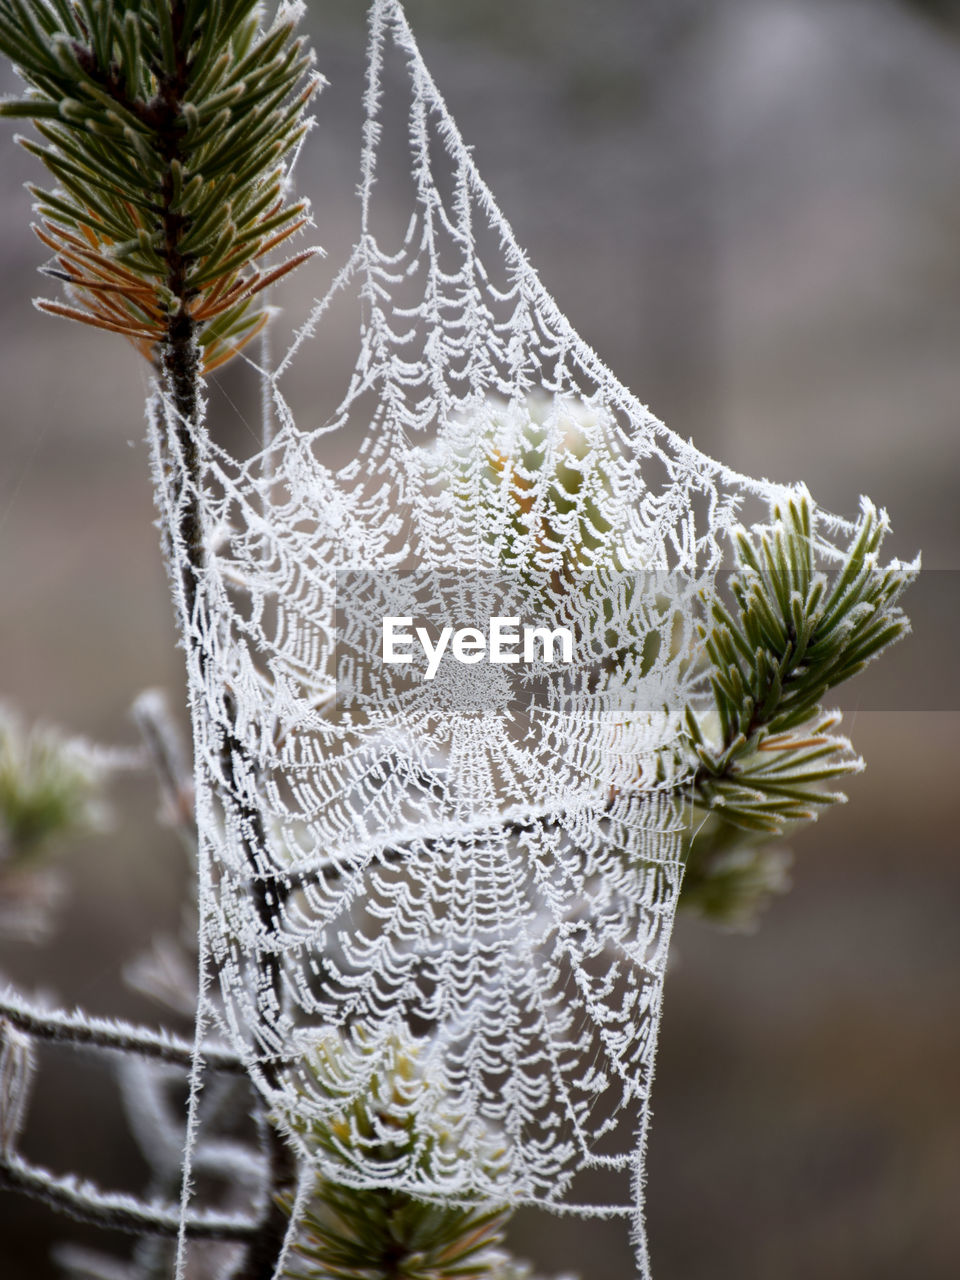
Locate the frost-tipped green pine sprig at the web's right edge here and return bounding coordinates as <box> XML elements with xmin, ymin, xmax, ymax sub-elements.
<box><xmin>682</xmin><ymin>492</ymin><xmax>916</xmax><ymax>923</ymax></box>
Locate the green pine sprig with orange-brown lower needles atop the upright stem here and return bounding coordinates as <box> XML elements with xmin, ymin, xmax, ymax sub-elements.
<box><xmin>0</xmin><ymin>0</ymin><xmax>320</xmax><ymax>372</ymax></box>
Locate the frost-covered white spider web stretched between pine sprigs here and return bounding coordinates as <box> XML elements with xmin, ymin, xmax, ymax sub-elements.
<box><xmin>152</xmin><ymin>0</ymin><xmax>870</xmax><ymax>1277</ymax></box>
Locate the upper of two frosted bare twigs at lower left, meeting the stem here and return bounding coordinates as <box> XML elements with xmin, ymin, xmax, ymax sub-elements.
<box><xmin>0</xmin><ymin>988</ymin><xmax>246</xmax><ymax>1075</ymax></box>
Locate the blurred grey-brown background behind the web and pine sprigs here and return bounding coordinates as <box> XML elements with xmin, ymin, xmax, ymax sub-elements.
<box><xmin>0</xmin><ymin>0</ymin><xmax>960</xmax><ymax>1280</ymax></box>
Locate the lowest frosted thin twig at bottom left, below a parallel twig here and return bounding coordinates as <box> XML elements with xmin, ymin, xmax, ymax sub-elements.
<box><xmin>0</xmin><ymin>1155</ymin><xmax>261</xmax><ymax>1240</ymax></box>
